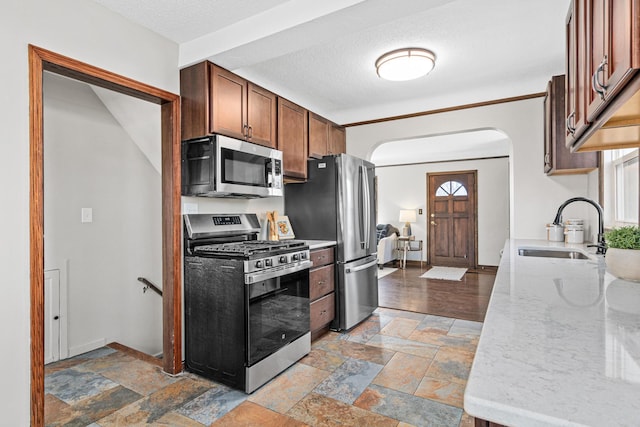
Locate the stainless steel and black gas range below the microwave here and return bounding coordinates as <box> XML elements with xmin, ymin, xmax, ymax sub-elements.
<box><xmin>184</xmin><ymin>214</ymin><xmax>312</xmax><ymax>393</ymax></box>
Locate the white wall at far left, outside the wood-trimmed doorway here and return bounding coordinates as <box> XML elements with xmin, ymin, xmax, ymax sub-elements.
<box><xmin>0</xmin><ymin>0</ymin><xmax>179</xmax><ymax>426</ymax></box>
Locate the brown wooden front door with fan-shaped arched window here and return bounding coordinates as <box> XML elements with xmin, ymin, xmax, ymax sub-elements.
<box><xmin>427</xmin><ymin>171</ymin><xmax>477</xmax><ymax>268</ymax></box>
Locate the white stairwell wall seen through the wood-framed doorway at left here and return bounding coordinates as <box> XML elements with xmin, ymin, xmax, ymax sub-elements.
<box><xmin>44</xmin><ymin>74</ymin><xmax>162</xmax><ymax>357</ymax></box>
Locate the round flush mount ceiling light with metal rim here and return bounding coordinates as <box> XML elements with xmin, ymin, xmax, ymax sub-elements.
<box><xmin>376</xmin><ymin>47</ymin><xmax>436</xmax><ymax>81</ymax></box>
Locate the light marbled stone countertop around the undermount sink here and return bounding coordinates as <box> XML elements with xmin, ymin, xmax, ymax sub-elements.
<box><xmin>464</xmin><ymin>240</ymin><xmax>640</xmax><ymax>427</ymax></box>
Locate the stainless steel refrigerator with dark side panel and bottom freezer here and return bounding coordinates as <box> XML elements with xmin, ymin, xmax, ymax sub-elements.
<box><xmin>284</xmin><ymin>154</ymin><xmax>378</xmax><ymax>329</ymax></box>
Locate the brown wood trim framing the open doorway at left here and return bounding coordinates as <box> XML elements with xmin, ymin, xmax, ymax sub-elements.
<box><xmin>29</xmin><ymin>45</ymin><xmax>182</xmax><ymax>427</ymax></box>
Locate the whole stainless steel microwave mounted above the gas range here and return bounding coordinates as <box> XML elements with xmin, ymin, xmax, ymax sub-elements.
<box><xmin>182</xmin><ymin>135</ymin><xmax>283</xmax><ymax>198</ymax></box>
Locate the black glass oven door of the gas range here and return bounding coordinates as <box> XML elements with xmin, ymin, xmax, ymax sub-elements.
<box><xmin>245</xmin><ymin>269</ymin><xmax>310</xmax><ymax>366</ymax></box>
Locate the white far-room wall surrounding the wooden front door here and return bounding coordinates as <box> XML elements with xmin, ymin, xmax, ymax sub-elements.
<box><xmin>376</xmin><ymin>158</ymin><xmax>509</xmax><ymax>266</ymax></box>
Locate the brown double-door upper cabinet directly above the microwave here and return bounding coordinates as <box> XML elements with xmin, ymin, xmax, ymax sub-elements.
<box><xmin>180</xmin><ymin>61</ymin><xmax>277</xmax><ymax>148</ymax></box>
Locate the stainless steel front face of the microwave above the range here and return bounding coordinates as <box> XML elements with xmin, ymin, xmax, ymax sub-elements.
<box><xmin>216</xmin><ymin>135</ymin><xmax>283</xmax><ymax>197</ymax></box>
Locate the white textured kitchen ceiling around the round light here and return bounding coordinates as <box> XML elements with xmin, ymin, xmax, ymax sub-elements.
<box><xmin>93</xmin><ymin>0</ymin><xmax>570</xmax><ymax>124</ymax></box>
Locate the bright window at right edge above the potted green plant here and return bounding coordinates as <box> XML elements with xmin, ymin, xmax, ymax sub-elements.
<box><xmin>611</xmin><ymin>149</ymin><xmax>639</xmax><ymax>225</ymax></box>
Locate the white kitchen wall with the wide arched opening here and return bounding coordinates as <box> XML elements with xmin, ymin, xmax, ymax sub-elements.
<box><xmin>347</xmin><ymin>98</ymin><xmax>592</xmax><ymax>239</ymax></box>
